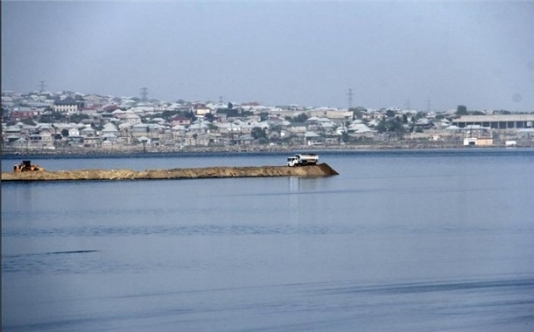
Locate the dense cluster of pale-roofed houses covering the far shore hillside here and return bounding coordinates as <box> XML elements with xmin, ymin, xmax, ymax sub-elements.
<box><xmin>2</xmin><ymin>92</ymin><xmax>534</xmax><ymax>150</ymax></box>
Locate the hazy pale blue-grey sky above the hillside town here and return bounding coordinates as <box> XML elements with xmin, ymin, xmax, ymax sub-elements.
<box><xmin>1</xmin><ymin>0</ymin><xmax>534</xmax><ymax>112</ymax></box>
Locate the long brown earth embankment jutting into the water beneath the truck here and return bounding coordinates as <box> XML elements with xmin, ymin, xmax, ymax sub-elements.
<box><xmin>2</xmin><ymin>164</ymin><xmax>338</xmax><ymax>181</ymax></box>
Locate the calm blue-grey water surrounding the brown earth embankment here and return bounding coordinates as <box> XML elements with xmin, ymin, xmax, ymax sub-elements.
<box><xmin>2</xmin><ymin>149</ymin><xmax>534</xmax><ymax>331</ymax></box>
